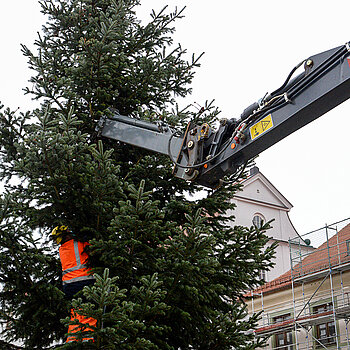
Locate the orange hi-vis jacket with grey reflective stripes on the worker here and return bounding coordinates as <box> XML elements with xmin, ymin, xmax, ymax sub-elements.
<box><xmin>59</xmin><ymin>239</ymin><xmax>94</xmax><ymax>284</ymax></box>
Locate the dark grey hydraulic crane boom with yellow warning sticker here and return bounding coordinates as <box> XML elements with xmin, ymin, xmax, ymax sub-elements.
<box><xmin>97</xmin><ymin>43</ymin><xmax>350</xmax><ymax>188</ymax></box>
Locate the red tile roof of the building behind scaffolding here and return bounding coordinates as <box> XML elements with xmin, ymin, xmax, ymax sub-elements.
<box><xmin>245</xmin><ymin>224</ymin><xmax>350</xmax><ymax>297</ymax></box>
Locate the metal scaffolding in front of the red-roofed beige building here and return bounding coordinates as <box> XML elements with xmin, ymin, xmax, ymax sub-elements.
<box><xmin>250</xmin><ymin>218</ymin><xmax>350</xmax><ymax>350</ymax></box>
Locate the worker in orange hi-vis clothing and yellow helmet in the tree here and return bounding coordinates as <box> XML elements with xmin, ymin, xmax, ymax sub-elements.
<box><xmin>51</xmin><ymin>225</ymin><xmax>96</xmax><ymax>342</ymax></box>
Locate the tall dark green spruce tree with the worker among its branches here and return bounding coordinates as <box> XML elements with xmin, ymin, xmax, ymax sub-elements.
<box><xmin>0</xmin><ymin>0</ymin><xmax>273</xmax><ymax>350</ymax></box>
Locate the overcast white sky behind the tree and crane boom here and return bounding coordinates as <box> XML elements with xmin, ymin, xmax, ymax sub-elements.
<box><xmin>0</xmin><ymin>0</ymin><xmax>350</xmax><ymax>234</ymax></box>
